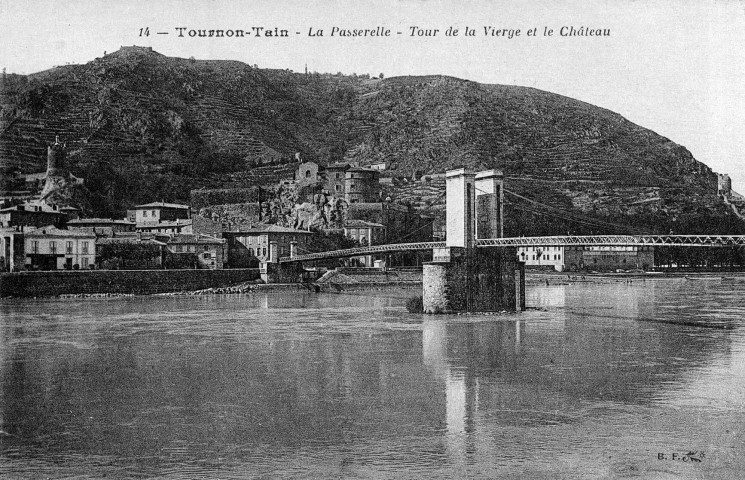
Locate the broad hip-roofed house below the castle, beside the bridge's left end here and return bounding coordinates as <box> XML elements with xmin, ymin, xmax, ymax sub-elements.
<box><xmin>223</xmin><ymin>224</ymin><xmax>313</xmax><ymax>268</ymax></box>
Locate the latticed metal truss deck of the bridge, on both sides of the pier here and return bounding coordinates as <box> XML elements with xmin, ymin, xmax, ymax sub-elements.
<box><xmin>279</xmin><ymin>235</ymin><xmax>745</xmax><ymax>263</ymax></box>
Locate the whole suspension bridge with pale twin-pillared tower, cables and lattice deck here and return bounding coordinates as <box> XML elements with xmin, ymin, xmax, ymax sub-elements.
<box><xmin>262</xmin><ymin>169</ymin><xmax>745</xmax><ymax>313</ymax></box>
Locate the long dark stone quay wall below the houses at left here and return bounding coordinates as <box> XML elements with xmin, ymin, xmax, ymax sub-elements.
<box><xmin>0</xmin><ymin>268</ymin><xmax>259</xmax><ymax>297</ymax></box>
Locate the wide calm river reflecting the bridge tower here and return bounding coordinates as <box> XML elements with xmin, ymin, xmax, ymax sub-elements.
<box><xmin>0</xmin><ymin>277</ymin><xmax>745</xmax><ymax>479</ymax></box>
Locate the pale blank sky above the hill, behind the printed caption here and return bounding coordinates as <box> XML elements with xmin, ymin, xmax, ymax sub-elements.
<box><xmin>0</xmin><ymin>0</ymin><xmax>745</xmax><ymax>193</ymax></box>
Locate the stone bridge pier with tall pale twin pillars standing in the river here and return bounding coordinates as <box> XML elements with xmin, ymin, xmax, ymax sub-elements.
<box><xmin>422</xmin><ymin>169</ymin><xmax>525</xmax><ymax>313</ymax></box>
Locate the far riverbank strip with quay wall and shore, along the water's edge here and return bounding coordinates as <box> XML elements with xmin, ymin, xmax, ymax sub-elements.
<box><xmin>7</xmin><ymin>268</ymin><xmax>745</xmax><ymax>298</ymax></box>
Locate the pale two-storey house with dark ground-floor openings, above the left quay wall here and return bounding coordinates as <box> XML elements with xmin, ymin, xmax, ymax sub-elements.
<box><xmin>24</xmin><ymin>225</ymin><xmax>96</xmax><ymax>270</ymax></box>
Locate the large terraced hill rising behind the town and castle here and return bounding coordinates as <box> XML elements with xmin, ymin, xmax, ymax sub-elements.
<box><xmin>0</xmin><ymin>47</ymin><xmax>741</xmax><ymax>233</ymax></box>
